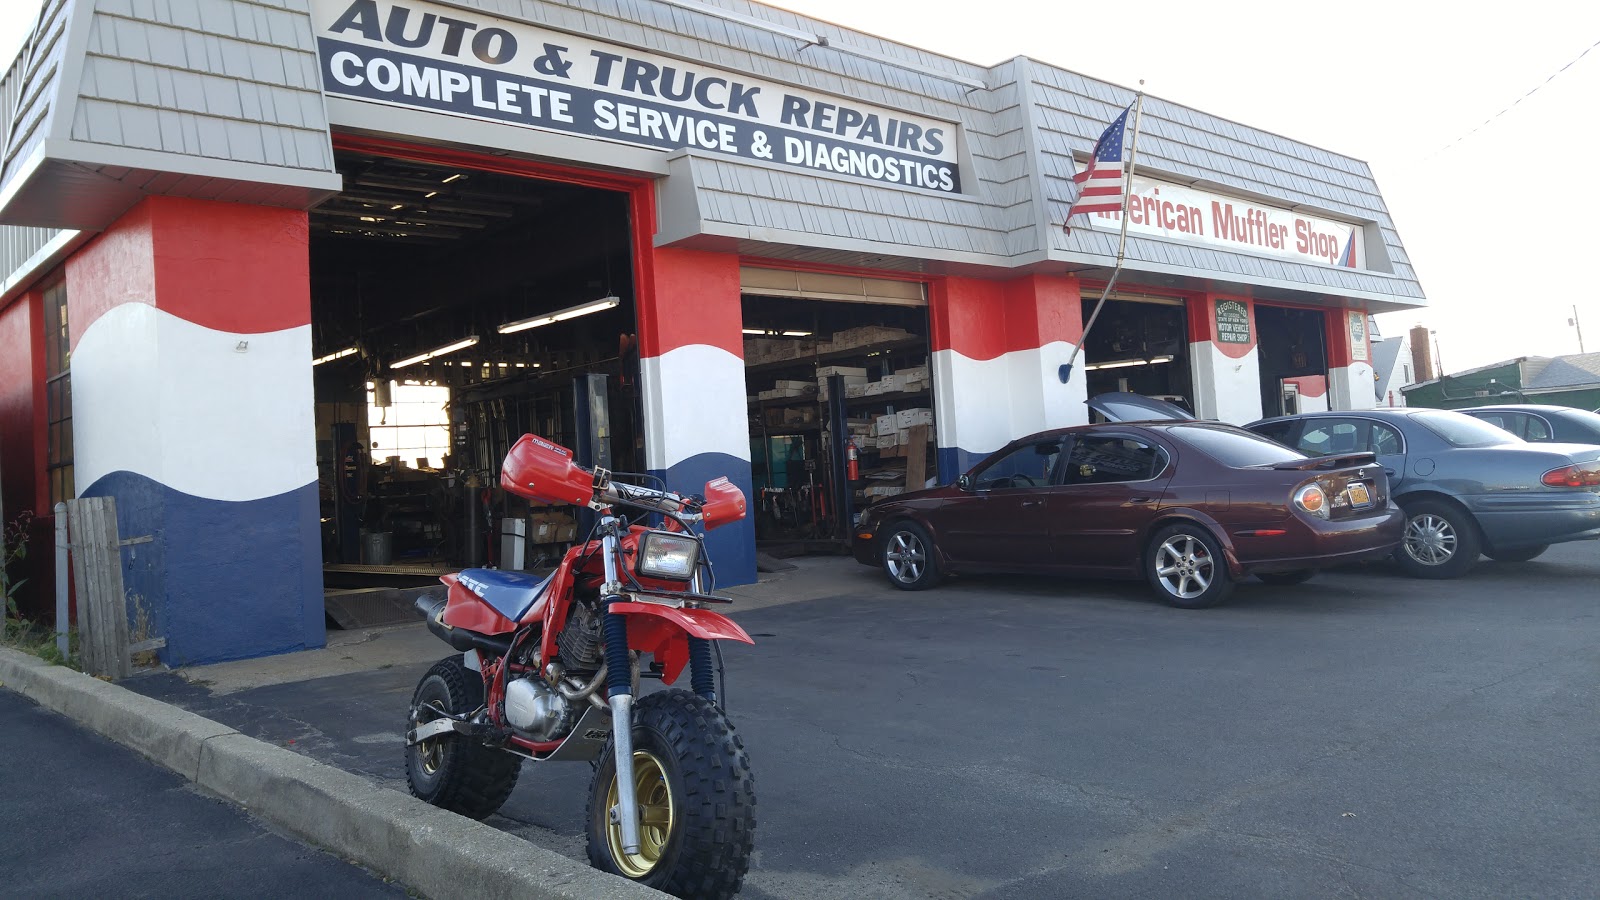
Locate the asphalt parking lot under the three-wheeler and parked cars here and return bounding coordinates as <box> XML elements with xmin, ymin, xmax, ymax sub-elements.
<box><xmin>126</xmin><ymin>543</ymin><xmax>1600</xmax><ymax>900</ymax></box>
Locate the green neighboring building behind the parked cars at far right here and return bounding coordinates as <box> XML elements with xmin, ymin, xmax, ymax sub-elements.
<box><xmin>1402</xmin><ymin>352</ymin><xmax>1600</xmax><ymax>410</ymax></box>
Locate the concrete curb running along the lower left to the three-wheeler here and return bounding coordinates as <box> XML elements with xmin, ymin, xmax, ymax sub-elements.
<box><xmin>0</xmin><ymin>649</ymin><xmax>667</xmax><ymax>900</ymax></box>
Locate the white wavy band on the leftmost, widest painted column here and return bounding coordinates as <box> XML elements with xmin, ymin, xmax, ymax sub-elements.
<box><xmin>72</xmin><ymin>303</ymin><xmax>317</xmax><ymax>501</ymax></box>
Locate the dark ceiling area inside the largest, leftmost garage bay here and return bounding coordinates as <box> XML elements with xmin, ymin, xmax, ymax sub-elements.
<box><xmin>310</xmin><ymin>152</ymin><xmax>635</xmax><ymax>386</ymax></box>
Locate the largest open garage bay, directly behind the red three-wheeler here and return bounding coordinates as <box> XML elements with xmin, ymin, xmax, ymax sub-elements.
<box><xmin>310</xmin><ymin>143</ymin><xmax>645</xmax><ymax>626</ymax></box>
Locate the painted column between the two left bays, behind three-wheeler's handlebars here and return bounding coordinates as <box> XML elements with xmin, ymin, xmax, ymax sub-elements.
<box><xmin>638</xmin><ymin>248</ymin><xmax>755</xmax><ymax>586</ymax></box>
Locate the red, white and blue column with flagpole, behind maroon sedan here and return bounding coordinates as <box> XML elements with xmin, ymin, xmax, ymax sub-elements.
<box><xmin>928</xmin><ymin>275</ymin><xmax>1088</xmax><ymax>484</ymax></box>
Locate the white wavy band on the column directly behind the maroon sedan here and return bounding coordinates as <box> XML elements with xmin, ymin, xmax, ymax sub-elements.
<box><xmin>933</xmin><ymin>341</ymin><xmax>1088</xmax><ymax>453</ymax></box>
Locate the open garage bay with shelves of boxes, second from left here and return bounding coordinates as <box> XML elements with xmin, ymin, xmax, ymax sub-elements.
<box><xmin>741</xmin><ymin>267</ymin><xmax>938</xmax><ymax>556</ymax></box>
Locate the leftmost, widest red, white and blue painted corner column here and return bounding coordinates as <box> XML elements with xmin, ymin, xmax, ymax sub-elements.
<box><xmin>67</xmin><ymin>197</ymin><xmax>323</xmax><ymax>665</ymax></box>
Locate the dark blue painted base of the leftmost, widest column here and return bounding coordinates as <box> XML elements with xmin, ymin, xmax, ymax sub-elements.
<box><xmin>82</xmin><ymin>471</ymin><xmax>325</xmax><ymax>666</ymax></box>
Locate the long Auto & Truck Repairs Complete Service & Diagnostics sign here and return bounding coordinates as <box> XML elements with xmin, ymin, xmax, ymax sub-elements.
<box><xmin>312</xmin><ymin>0</ymin><xmax>962</xmax><ymax>194</ymax></box>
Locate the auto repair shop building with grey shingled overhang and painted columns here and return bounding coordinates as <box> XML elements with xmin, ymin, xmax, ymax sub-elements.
<box><xmin>0</xmin><ymin>0</ymin><xmax>1424</xmax><ymax>665</ymax></box>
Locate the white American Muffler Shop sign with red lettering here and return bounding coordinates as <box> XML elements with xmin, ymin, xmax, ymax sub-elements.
<box><xmin>1090</xmin><ymin>168</ymin><xmax>1366</xmax><ymax>269</ymax></box>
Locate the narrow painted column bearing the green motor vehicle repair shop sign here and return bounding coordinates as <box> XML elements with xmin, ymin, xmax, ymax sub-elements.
<box><xmin>1186</xmin><ymin>295</ymin><xmax>1261</xmax><ymax>424</ymax></box>
